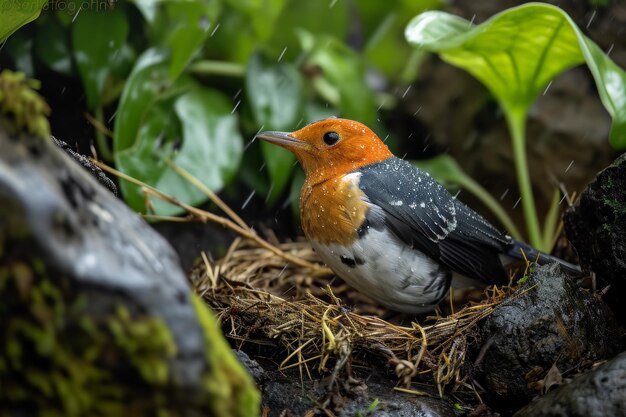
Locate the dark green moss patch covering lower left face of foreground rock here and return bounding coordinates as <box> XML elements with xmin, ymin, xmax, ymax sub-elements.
<box><xmin>0</xmin><ymin>260</ymin><xmax>181</xmax><ymax>417</ymax></box>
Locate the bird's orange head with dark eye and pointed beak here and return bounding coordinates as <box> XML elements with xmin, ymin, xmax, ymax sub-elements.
<box><xmin>257</xmin><ymin>118</ymin><xmax>392</xmax><ymax>184</ymax></box>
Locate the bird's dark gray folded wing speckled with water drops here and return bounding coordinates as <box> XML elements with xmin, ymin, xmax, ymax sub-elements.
<box><xmin>358</xmin><ymin>157</ymin><xmax>511</xmax><ymax>283</ymax></box>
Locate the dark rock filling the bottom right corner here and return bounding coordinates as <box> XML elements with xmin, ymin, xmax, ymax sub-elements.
<box><xmin>514</xmin><ymin>352</ymin><xmax>626</xmax><ymax>417</ymax></box>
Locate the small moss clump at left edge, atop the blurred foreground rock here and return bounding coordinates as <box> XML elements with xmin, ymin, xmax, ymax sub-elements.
<box><xmin>0</xmin><ymin>70</ymin><xmax>50</xmax><ymax>138</ymax></box>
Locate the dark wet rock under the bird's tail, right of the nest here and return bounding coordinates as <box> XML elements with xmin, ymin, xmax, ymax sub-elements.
<box><xmin>477</xmin><ymin>264</ymin><xmax>624</xmax><ymax>410</ymax></box>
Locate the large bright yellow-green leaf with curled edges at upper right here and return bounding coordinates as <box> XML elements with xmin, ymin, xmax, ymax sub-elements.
<box><xmin>405</xmin><ymin>3</ymin><xmax>626</xmax><ymax>149</ymax></box>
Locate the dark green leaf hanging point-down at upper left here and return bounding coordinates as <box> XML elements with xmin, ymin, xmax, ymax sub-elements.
<box><xmin>72</xmin><ymin>9</ymin><xmax>128</xmax><ymax>110</ymax></box>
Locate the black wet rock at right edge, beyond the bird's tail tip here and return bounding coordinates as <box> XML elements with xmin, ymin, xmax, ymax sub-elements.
<box><xmin>564</xmin><ymin>154</ymin><xmax>626</xmax><ymax>324</ymax></box>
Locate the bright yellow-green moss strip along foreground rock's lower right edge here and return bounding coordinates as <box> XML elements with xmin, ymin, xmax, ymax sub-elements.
<box><xmin>192</xmin><ymin>295</ymin><xmax>260</xmax><ymax>417</ymax></box>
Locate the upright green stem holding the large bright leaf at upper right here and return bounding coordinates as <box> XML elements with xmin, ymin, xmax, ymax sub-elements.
<box><xmin>505</xmin><ymin>109</ymin><xmax>545</xmax><ymax>250</ymax></box>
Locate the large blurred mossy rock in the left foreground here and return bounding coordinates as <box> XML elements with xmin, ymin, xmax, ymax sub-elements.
<box><xmin>0</xmin><ymin>129</ymin><xmax>258</xmax><ymax>416</ymax></box>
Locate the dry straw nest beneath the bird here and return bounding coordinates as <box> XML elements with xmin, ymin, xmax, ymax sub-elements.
<box><xmin>191</xmin><ymin>239</ymin><xmax>512</xmax><ymax>395</ymax></box>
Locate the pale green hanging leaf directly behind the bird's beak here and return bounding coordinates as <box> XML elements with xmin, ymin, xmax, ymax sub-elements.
<box><xmin>245</xmin><ymin>54</ymin><xmax>304</xmax><ymax>203</ymax></box>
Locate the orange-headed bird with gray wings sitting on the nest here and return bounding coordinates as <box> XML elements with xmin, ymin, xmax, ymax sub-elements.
<box><xmin>257</xmin><ymin>117</ymin><xmax>578</xmax><ymax>314</ymax></box>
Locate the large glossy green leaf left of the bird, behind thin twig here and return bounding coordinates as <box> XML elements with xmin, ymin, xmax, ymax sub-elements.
<box><xmin>114</xmin><ymin>49</ymin><xmax>242</xmax><ymax>214</ymax></box>
